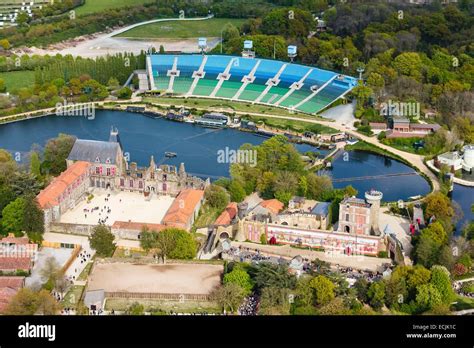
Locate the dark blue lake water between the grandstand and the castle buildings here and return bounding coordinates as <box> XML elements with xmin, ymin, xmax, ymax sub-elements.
<box><xmin>0</xmin><ymin>111</ymin><xmax>468</xmax><ymax>209</ymax></box>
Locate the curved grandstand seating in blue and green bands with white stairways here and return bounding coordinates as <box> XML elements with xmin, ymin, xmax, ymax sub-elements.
<box><xmin>151</xmin><ymin>54</ymin><xmax>357</xmax><ymax>114</ymax></box>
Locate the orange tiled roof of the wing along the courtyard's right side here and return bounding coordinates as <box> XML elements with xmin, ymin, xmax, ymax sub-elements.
<box><xmin>161</xmin><ymin>189</ymin><xmax>204</xmax><ymax>226</ymax></box>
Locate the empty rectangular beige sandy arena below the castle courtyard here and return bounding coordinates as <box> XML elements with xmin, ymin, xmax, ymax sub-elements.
<box><xmin>88</xmin><ymin>263</ymin><xmax>223</xmax><ymax>295</ymax></box>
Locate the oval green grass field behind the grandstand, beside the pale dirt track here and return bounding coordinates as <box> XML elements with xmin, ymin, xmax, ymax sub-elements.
<box><xmin>117</xmin><ymin>18</ymin><xmax>245</xmax><ymax>39</ymax></box>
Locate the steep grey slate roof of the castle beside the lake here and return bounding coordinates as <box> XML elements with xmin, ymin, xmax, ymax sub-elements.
<box><xmin>67</xmin><ymin>139</ymin><xmax>120</xmax><ymax>164</ymax></box>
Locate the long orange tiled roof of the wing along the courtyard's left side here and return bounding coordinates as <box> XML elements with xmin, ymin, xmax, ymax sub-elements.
<box><xmin>37</xmin><ymin>161</ymin><xmax>90</xmax><ymax>209</ymax></box>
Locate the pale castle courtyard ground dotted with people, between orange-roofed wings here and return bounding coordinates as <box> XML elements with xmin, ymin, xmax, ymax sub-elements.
<box><xmin>60</xmin><ymin>190</ymin><xmax>174</xmax><ymax>226</ymax></box>
